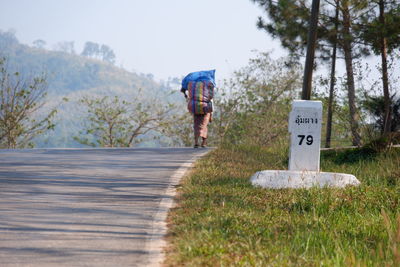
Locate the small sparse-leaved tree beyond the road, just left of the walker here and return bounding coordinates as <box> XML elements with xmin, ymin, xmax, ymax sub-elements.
<box><xmin>74</xmin><ymin>96</ymin><xmax>173</xmax><ymax>147</ymax></box>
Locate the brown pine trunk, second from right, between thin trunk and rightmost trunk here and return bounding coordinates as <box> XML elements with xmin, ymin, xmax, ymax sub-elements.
<box><xmin>342</xmin><ymin>5</ymin><xmax>361</xmax><ymax>146</ymax></box>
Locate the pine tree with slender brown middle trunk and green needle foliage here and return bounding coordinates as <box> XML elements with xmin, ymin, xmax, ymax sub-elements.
<box><xmin>252</xmin><ymin>0</ymin><xmax>368</xmax><ymax>145</ymax></box>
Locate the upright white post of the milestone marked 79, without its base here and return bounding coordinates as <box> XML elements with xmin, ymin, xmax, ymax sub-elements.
<box><xmin>289</xmin><ymin>100</ymin><xmax>322</xmax><ymax>172</ymax></box>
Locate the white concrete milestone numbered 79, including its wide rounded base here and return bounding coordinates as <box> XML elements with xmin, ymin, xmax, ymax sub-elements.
<box><xmin>250</xmin><ymin>100</ymin><xmax>360</xmax><ymax>189</ymax></box>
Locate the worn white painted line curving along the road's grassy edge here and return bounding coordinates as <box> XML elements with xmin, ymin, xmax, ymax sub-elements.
<box><xmin>146</xmin><ymin>149</ymin><xmax>212</xmax><ymax>267</ymax></box>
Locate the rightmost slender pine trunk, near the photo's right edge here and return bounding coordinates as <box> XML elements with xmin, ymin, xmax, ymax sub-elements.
<box><xmin>379</xmin><ymin>0</ymin><xmax>391</xmax><ymax>134</ymax></box>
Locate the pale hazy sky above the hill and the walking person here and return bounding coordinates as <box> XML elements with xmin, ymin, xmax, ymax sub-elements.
<box><xmin>0</xmin><ymin>0</ymin><xmax>284</xmax><ymax>80</ymax></box>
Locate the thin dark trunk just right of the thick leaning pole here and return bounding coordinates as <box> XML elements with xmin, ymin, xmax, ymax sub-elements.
<box><xmin>325</xmin><ymin>1</ymin><xmax>339</xmax><ymax>148</ymax></box>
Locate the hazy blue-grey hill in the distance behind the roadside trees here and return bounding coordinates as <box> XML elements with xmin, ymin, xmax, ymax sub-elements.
<box><xmin>0</xmin><ymin>31</ymin><xmax>180</xmax><ymax>147</ymax></box>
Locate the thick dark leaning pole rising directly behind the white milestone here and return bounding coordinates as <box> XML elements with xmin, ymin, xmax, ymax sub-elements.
<box><xmin>301</xmin><ymin>0</ymin><xmax>320</xmax><ymax>100</ymax></box>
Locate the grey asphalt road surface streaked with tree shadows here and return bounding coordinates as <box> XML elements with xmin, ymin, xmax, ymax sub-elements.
<box><xmin>0</xmin><ymin>148</ymin><xmax>206</xmax><ymax>267</ymax></box>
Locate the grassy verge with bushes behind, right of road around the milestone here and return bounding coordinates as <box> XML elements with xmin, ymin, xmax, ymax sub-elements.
<box><xmin>165</xmin><ymin>48</ymin><xmax>400</xmax><ymax>266</ymax></box>
